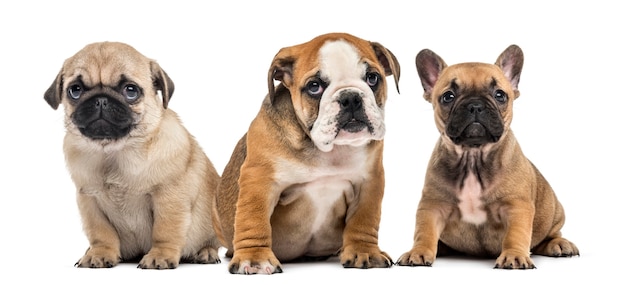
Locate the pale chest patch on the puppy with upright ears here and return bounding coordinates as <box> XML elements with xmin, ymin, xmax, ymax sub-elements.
<box><xmin>458</xmin><ymin>173</ymin><xmax>487</xmax><ymax>225</ymax></box>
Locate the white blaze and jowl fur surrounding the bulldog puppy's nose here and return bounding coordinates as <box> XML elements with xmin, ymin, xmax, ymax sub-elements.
<box><xmin>311</xmin><ymin>40</ymin><xmax>385</xmax><ymax>152</ymax></box>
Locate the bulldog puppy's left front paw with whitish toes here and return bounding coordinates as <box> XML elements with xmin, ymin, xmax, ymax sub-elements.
<box><xmin>228</xmin><ymin>247</ymin><xmax>283</xmax><ymax>274</ymax></box>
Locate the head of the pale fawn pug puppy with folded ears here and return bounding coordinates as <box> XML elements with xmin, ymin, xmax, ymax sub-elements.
<box><xmin>44</xmin><ymin>42</ymin><xmax>173</xmax><ymax>144</ymax></box>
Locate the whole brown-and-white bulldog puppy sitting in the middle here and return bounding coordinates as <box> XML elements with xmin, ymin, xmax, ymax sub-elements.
<box><xmin>214</xmin><ymin>33</ymin><xmax>400</xmax><ymax>274</ymax></box>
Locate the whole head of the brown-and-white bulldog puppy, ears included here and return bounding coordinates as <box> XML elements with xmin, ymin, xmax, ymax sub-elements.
<box><xmin>270</xmin><ymin>33</ymin><xmax>399</xmax><ymax>152</ymax></box>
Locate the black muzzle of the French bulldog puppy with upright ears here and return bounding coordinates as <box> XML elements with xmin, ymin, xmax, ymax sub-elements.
<box><xmin>446</xmin><ymin>98</ymin><xmax>504</xmax><ymax>147</ymax></box>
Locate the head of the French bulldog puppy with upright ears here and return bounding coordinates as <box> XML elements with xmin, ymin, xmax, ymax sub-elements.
<box><xmin>416</xmin><ymin>46</ymin><xmax>522</xmax><ymax>148</ymax></box>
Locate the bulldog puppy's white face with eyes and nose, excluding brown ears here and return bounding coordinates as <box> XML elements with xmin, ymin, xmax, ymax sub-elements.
<box><xmin>300</xmin><ymin>40</ymin><xmax>385</xmax><ymax>151</ymax></box>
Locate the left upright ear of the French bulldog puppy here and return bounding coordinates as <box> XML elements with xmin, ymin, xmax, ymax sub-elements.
<box><xmin>415</xmin><ymin>49</ymin><xmax>447</xmax><ymax>102</ymax></box>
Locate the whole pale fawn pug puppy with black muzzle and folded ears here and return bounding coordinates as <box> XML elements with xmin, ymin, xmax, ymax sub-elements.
<box><xmin>44</xmin><ymin>42</ymin><xmax>219</xmax><ymax>269</ymax></box>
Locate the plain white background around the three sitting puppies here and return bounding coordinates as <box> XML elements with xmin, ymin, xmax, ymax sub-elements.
<box><xmin>0</xmin><ymin>0</ymin><xmax>626</xmax><ymax>284</ymax></box>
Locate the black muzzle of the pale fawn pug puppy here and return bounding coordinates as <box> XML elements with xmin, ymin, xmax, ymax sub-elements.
<box><xmin>72</xmin><ymin>95</ymin><xmax>133</xmax><ymax>140</ymax></box>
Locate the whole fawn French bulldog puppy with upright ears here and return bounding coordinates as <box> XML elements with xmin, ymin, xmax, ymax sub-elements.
<box><xmin>398</xmin><ymin>45</ymin><xmax>578</xmax><ymax>269</ymax></box>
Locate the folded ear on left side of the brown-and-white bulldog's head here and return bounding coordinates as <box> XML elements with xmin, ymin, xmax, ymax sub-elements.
<box><xmin>267</xmin><ymin>48</ymin><xmax>296</xmax><ymax>104</ymax></box>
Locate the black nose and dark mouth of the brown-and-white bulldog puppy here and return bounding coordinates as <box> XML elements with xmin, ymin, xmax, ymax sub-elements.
<box><xmin>337</xmin><ymin>91</ymin><xmax>373</xmax><ymax>133</ymax></box>
